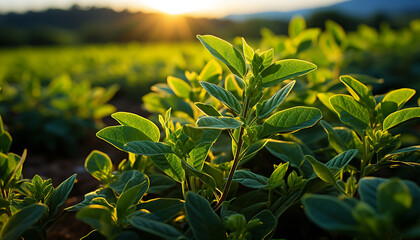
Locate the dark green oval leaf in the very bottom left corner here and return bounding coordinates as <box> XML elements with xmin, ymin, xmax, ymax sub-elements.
<box><xmin>0</xmin><ymin>204</ymin><xmax>47</xmax><ymax>240</ymax></box>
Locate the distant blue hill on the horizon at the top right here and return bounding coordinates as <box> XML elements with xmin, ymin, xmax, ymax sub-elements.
<box><xmin>224</xmin><ymin>0</ymin><xmax>420</xmax><ymax>21</ymax></box>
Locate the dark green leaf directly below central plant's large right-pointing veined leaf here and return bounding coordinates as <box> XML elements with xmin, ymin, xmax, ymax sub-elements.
<box><xmin>265</xmin><ymin>140</ymin><xmax>305</xmax><ymax>168</ymax></box>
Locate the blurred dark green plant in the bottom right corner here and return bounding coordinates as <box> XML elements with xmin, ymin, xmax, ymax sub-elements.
<box><xmin>302</xmin><ymin>177</ymin><xmax>420</xmax><ymax>239</ymax></box>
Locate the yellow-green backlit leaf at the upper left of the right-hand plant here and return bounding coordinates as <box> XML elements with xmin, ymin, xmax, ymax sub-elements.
<box><xmin>340</xmin><ymin>75</ymin><xmax>376</xmax><ymax>110</ymax></box>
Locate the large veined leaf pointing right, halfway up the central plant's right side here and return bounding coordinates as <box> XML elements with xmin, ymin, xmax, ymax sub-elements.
<box><xmin>261</xmin><ymin>106</ymin><xmax>322</xmax><ymax>137</ymax></box>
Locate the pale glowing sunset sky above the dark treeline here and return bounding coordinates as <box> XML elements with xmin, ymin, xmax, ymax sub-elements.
<box><xmin>0</xmin><ymin>0</ymin><xmax>346</xmax><ymax>17</ymax></box>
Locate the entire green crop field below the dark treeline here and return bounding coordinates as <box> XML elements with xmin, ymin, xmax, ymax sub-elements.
<box><xmin>0</xmin><ymin>17</ymin><xmax>420</xmax><ymax>240</ymax></box>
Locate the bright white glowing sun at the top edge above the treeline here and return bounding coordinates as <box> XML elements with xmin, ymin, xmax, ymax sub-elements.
<box><xmin>147</xmin><ymin>0</ymin><xmax>207</xmax><ymax>15</ymax></box>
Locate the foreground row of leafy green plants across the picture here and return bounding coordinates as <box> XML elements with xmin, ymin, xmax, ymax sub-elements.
<box><xmin>0</xmin><ymin>35</ymin><xmax>420</xmax><ymax>240</ymax></box>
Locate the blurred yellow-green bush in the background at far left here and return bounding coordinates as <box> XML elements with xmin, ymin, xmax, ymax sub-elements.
<box><xmin>0</xmin><ymin>76</ymin><xmax>118</xmax><ymax>155</ymax></box>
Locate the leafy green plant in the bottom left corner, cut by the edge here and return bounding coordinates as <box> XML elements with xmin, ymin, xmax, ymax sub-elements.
<box><xmin>0</xmin><ymin>114</ymin><xmax>76</xmax><ymax>240</ymax></box>
